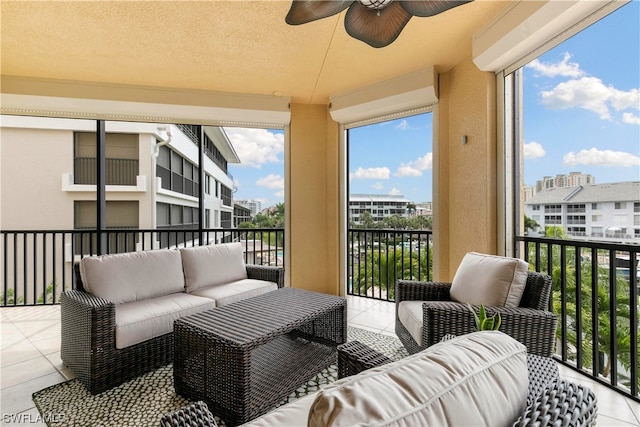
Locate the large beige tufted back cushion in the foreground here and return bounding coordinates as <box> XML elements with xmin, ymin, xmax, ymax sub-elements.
<box><xmin>308</xmin><ymin>331</ymin><xmax>528</xmax><ymax>427</ymax></box>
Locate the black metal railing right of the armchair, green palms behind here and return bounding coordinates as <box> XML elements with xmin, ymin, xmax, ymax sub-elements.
<box><xmin>516</xmin><ymin>237</ymin><xmax>640</xmax><ymax>401</ymax></box>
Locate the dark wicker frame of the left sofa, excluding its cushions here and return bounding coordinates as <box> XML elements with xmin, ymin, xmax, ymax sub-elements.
<box><xmin>60</xmin><ymin>264</ymin><xmax>284</xmax><ymax>394</ymax></box>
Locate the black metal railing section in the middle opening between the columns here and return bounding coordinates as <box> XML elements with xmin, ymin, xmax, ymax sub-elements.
<box><xmin>347</xmin><ymin>228</ymin><xmax>433</xmax><ymax>301</ymax></box>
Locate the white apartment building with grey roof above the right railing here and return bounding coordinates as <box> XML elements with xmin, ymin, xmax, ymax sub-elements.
<box><xmin>525</xmin><ymin>181</ymin><xmax>640</xmax><ymax>243</ymax></box>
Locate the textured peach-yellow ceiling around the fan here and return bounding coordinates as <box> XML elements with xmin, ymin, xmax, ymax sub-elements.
<box><xmin>1</xmin><ymin>0</ymin><xmax>508</xmax><ymax>104</ymax></box>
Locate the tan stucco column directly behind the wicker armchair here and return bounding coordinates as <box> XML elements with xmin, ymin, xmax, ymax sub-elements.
<box><xmin>433</xmin><ymin>58</ymin><xmax>498</xmax><ymax>281</ymax></box>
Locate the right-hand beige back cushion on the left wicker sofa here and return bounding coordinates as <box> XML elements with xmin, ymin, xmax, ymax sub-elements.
<box><xmin>180</xmin><ymin>243</ymin><xmax>247</xmax><ymax>292</ymax></box>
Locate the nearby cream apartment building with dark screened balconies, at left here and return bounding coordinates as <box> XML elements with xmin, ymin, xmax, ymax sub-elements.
<box><xmin>0</xmin><ymin>115</ymin><xmax>240</xmax><ymax>247</ymax></box>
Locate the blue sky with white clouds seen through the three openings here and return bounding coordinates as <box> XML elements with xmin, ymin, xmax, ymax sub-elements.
<box><xmin>225</xmin><ymin>0</ymin><xmax>640</xmax><ymax>207</ymax></box>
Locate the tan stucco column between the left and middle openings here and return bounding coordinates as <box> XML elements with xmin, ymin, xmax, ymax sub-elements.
<box><xmin>285</xmin><ymin>104</ymin><xmax>340</xmax><ymax>295</ymax></box>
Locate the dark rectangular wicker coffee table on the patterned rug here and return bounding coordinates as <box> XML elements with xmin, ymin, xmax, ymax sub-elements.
<box><xmin>173</xmin><ymin>288</ymin><xmax>347</xmax><ymax>425</ymax></box>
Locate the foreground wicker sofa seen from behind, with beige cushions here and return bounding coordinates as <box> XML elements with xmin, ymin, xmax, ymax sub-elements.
<box><xmin>161</xmin><ymin>331</ymin><xmax>597</xmax><ymax>427</ymax></box>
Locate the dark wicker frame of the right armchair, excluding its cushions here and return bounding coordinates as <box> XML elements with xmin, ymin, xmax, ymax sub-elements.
<box><xmin>395</xmin><ymin>271</ymin><xmax>558</xmax><ymax>357</ymax></box>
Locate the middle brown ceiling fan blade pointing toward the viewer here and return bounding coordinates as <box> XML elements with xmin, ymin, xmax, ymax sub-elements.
<box><xmin>344</xmin><ymin>2</ymin><xmax>411</xmax><ymax>47</ymax></box>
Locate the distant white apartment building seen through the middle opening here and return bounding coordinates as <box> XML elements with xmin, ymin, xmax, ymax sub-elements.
<box><xmin>348</xmin><ymin>194</ymin><xmax>411</xmax><ymax>225</ymax></box>
